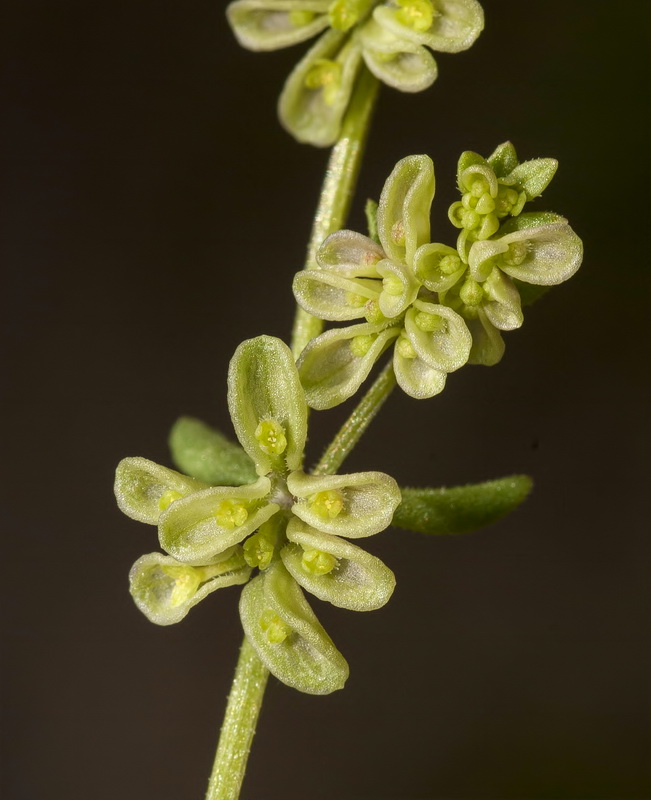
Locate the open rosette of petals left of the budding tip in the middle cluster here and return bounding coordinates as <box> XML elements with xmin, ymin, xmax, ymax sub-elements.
<box><xmin>294</xmin><ymin>156</ymin><xmax>472</xmax><ymax>409</ymax></box>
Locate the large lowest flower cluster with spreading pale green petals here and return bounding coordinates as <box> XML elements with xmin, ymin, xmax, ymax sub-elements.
<box><xmin>115</xmin><ymin>336</ymin><xmax>400</xmax><ymax>694</ymax></box>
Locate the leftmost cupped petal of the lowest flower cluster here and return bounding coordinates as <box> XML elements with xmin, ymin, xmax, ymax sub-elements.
<box><xmin>113</xmin><ymin>458</ymin><xmax>208</xmax><ymax>525</ymax></box>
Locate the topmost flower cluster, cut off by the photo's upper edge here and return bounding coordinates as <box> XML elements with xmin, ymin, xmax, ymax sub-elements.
<box><xmin>227</xmin><ymin>0</ymin><xmax>484</xmax><ymax>146</ymax></box>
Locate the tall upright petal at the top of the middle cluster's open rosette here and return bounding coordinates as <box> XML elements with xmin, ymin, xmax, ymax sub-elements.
<box><xmin>377</xmin><ymin>156</ymin><xmax>435</xmax><ymax>265</ymax></box>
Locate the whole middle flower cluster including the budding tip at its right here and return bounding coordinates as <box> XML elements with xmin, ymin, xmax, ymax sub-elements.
<box><xmin>294</xmin><ymin>142</ymin><xmax>582</xmax><ymax>409</ymax></box>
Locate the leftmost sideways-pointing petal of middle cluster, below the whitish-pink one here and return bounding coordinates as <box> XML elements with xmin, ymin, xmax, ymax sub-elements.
<box><xmin>292</xmin><ymin>269</ymin><xmax>382</xmax><ymax>322</ymax></box>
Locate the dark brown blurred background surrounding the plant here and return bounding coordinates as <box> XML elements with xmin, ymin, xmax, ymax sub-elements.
<box><xmin>0</xmin><ymin>0</ymin><xmax>651</xmax><ymax>800</ymax></box>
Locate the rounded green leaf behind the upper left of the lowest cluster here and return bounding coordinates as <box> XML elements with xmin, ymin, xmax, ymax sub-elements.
<box><xmin>169</xmin><ymin>417</ymin><xmax>258</xmax><ymax>486</ymax></box>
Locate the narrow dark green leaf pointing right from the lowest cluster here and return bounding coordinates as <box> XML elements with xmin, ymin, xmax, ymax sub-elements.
<box><xmin>393</xmin><ymin>475</ymin><xmax>533</xmax><ymax>535</ymax></box>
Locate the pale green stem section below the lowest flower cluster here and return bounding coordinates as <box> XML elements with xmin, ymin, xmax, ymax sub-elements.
<box><xmin>206</xmin><ymin>637</ymin><xmax>269</xmax><ymax>800</ymax></box>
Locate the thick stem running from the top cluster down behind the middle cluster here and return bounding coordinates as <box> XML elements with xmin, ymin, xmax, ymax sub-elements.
<box><xmin>291</xmin><ymin>65</ymin><xmax>379</xmax><ymax>358</ymax></box>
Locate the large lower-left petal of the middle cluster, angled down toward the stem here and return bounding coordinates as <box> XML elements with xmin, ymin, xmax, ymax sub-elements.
<box><xmin>297</xmin><ymin>324</ymin><xmax>400</xmax><ymax>411</ymax></box>
